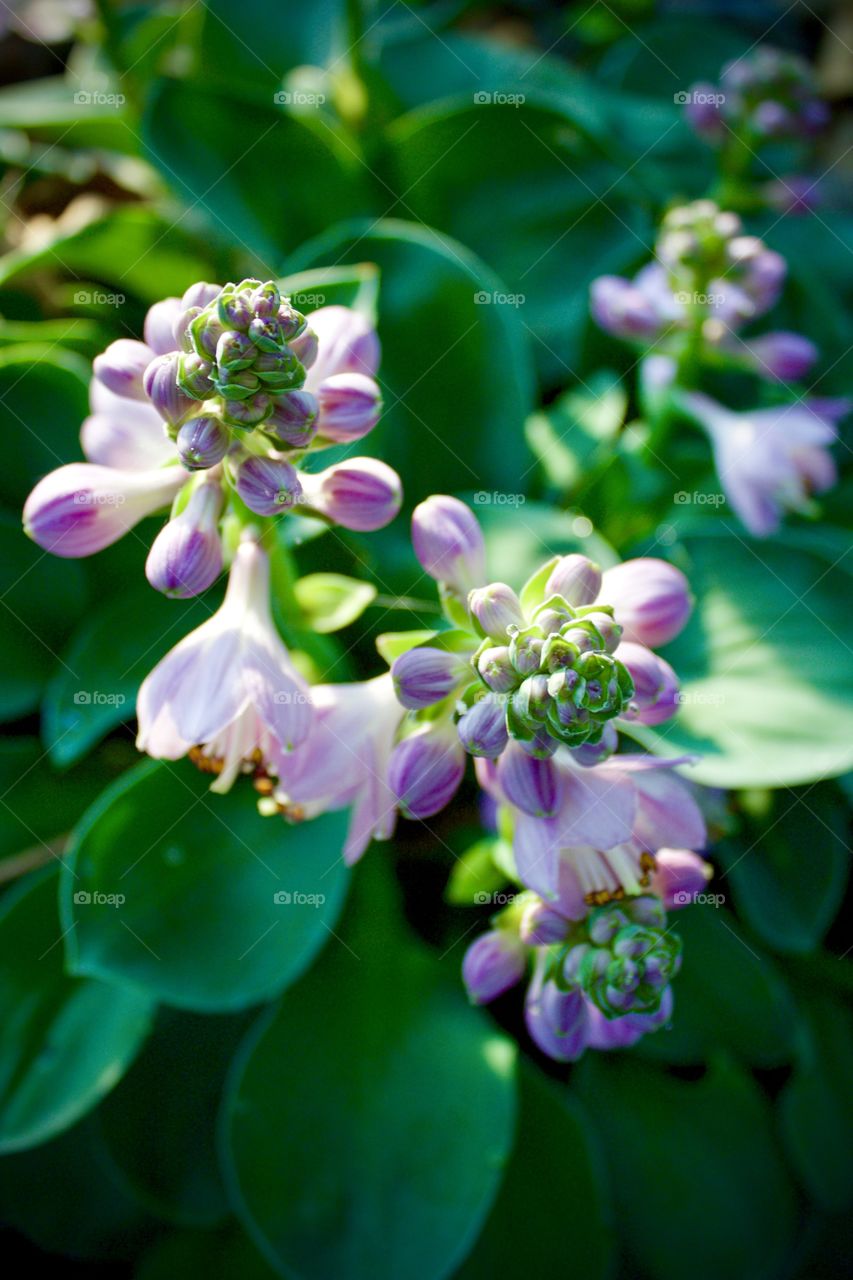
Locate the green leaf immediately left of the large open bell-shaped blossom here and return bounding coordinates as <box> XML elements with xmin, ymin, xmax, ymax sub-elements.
<box><xmin>42</xmin><ymin>579</ymin><xmax>218</xmax><ymax>765</ymax></box>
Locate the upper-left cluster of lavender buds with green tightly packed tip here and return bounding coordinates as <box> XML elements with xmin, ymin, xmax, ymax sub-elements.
<box><xmin>24</xmin><ymin>280</ymin><xmax>401</xmax><ymax>596</ymax></box>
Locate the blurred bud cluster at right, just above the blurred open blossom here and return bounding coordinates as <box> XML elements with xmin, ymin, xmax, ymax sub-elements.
<box><xmin>590</xmin><ymin>200</ymin><xmax>818</xmax><ymax>381</ymax></box>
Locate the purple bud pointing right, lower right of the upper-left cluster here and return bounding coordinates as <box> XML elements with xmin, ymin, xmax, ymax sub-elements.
<box><xmin>302</xmin><ymin>458</ymin><xmax>402</xmax><ymax>532</ymax></box>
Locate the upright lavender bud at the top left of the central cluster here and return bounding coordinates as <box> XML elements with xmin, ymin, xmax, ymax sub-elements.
<box><xmin>411</xmin><ymin>494</ymin><xmax>485</xmax><ymax>596</ymax></box>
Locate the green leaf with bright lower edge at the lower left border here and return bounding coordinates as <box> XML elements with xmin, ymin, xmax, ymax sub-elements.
<box><xmin>0</xmin><ymin>868</ymin><xmax>152</xmax><ymax>1153</ymax></box>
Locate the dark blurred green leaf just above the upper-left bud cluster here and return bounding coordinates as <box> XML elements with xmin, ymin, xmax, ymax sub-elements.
<box><xmin>143</xmin><ymin>79</ymin><xmax>370</xmax><ymax>259</ymax></box>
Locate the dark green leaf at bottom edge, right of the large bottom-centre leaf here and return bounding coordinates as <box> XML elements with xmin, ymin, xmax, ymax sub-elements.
<box><xmin>456</xmin><ymin>1064</ymin><xmax>615</xmax><ymax>1280</ymax></box>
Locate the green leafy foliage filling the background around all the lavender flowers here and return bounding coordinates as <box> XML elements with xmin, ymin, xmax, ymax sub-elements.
<box><xmin>0</xmin><ymin>0</ymin><xmax>853</xmax><ymax>1280</ymax></box>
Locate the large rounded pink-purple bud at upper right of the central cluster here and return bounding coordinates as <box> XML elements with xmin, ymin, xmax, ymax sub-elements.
<box><xmin>602</xmin><ymin>558</ymin><xmax>693</xmax><ymax>649</ymax></box>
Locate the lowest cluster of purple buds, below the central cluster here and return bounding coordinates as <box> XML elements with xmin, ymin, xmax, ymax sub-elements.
<box><xmin>462</xmin><ymin>849</ymin><xmax>711</xmax><ymax>1062</ymax></box>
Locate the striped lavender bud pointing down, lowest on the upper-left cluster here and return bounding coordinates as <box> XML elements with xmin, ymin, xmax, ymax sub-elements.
<box><xmin>145</xmin><ymin>483</ymin><xmax>222</xmax><ymax>600</ymax></box>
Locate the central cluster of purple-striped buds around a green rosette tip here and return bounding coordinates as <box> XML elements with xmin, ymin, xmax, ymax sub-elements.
<box><xmin>392</xmin><ymin>495</ymin><xmax>690</xmax><ymax>817</ymax></box>
